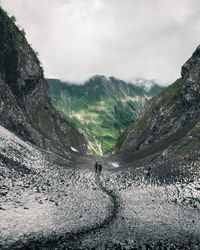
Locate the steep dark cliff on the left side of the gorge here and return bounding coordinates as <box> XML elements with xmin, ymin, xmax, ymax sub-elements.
<box><xmin>0</xmin><ymin>8</ymin><xmax>86</xmax><ymax>153</ymax></box>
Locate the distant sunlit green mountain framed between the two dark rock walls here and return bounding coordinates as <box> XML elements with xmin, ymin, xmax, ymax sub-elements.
<box><xmin>48</xmin><ymin>75</ymin><xmax>162</xmax><ymax>155</ymax></box>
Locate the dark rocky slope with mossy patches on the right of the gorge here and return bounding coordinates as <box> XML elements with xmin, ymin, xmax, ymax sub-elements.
<box><xmin>118</xmin><ymin>46</ymin><xmax>200</xmax><ymax>159</ymax></box>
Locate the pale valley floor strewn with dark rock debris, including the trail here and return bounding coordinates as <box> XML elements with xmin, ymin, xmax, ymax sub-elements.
<box><xmin>0</xmin><ymin>127</ymin><xmax>200</xmax><ymax>249</ymax></box>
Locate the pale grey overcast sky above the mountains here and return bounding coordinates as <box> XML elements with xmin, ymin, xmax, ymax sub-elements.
<box><xmin>1</xmin><ymin>0</ymin><xmax>200</xmax><ymax>84</ymax></box>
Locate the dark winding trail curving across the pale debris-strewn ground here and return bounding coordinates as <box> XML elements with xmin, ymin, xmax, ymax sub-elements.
<box><xmin>11</xmin><ymin>174</ymin><xmax>120</xmax><ymax>250</ymax></box>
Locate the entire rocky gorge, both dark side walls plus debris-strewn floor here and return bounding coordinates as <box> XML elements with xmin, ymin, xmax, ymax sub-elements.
<box><xmin>0</xmin><ymin>4</ymin><xmax>200</xmax><ymax>250</ymax></box>
